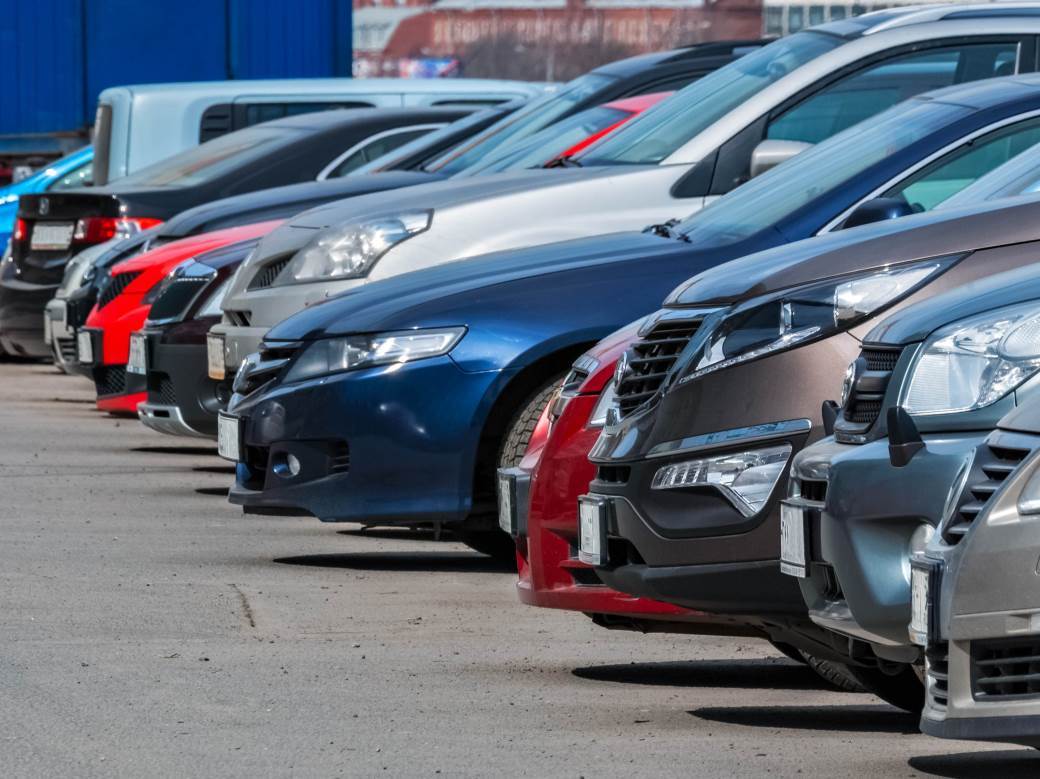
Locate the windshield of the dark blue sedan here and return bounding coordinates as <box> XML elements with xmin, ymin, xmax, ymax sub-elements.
<box><xmin>676</xmin><ymin>100</ymin><xmax>971</xmax><ymax>245</ymax></box>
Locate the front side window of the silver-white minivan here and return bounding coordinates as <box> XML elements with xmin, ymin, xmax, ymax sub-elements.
<box><xmin>765</xmin><ymin>41</ymin><xmax>1018</xmax><ymax>144</ymax></box>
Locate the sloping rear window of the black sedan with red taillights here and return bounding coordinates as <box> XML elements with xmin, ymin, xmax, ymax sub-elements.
<box><xmin>120</xmin><ymin>127</ymin><xmax>302</xmax><ymax>187</ymax></box>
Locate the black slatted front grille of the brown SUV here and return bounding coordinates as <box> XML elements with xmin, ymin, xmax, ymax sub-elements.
<box><xmin>615</xmin><ymin>316</ymin><xmax>703</xmax><ymax>417</ymax></box>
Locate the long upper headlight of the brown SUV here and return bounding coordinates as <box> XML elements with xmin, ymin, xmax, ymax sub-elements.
<box><xmin>681</xmin><ymin>257</ymin><xmax>959</xmax><ymax>382</ymax></box>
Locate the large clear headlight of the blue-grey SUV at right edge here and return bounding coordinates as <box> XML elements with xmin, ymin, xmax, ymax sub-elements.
<box><xmin>900</xmin><ymin>303</ymin><xmax>1040</xmax><ymax>415</ymax></box>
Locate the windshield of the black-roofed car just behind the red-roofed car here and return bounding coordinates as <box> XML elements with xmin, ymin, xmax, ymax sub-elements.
<box><xmin>423</xmin><ymin>73</ymin><xmax>614</xmax><ymax>174</ymax></box>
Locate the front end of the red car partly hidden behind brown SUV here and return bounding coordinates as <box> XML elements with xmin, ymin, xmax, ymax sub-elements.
<box><xmin>500</xmin><ymin>323</ymin><xmax>757</xmax><ymax>635</ymax></box>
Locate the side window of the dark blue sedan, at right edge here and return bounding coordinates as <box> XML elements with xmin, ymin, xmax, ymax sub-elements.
<box><xmin>882</xmin><ymin>118</ymin><xmax>1040</xmax><ymax>211</ymax></box>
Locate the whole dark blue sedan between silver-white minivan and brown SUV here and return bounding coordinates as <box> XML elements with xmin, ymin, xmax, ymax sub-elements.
<box><xmin>225</xmin><ymin>77</ymin><xmax>1040</xmax><ymax>550</ymax></box>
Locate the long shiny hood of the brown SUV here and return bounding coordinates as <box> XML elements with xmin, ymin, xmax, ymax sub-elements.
<box><xmin>666</xmin><ymin>196</ymin><xmax>1040</xmax><ymax>307</ymax></box>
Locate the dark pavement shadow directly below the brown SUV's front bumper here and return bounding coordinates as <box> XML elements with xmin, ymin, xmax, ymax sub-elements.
<box><xmin>572</xmin><ymin>660</ymin><xmax>830</xmax><ymax>690</ymax></box>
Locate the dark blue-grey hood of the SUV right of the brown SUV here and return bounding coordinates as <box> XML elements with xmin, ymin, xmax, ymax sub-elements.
<box><xmin>864</xmin><ymin>260</ymin><xmax>1040</xmax><ymax>345</ymax></box>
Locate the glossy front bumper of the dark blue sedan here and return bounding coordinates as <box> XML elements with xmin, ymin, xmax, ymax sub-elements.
<box><xmin>229</xmin><ymin>357</ymin><xmax>508</xmax><ymax>524</ymax></box>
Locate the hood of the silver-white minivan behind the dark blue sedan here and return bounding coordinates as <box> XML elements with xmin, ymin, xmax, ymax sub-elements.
<box><xmin>290</xmin><ymin>165</ymin><xmax>652</xmax><ymax>230</ymax></box>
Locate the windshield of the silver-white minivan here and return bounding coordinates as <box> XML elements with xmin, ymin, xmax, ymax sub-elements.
<box><xmin>581</xmin><ymin>32</ymin><xmax>844</xmax><ymax>165</ymax></box>
